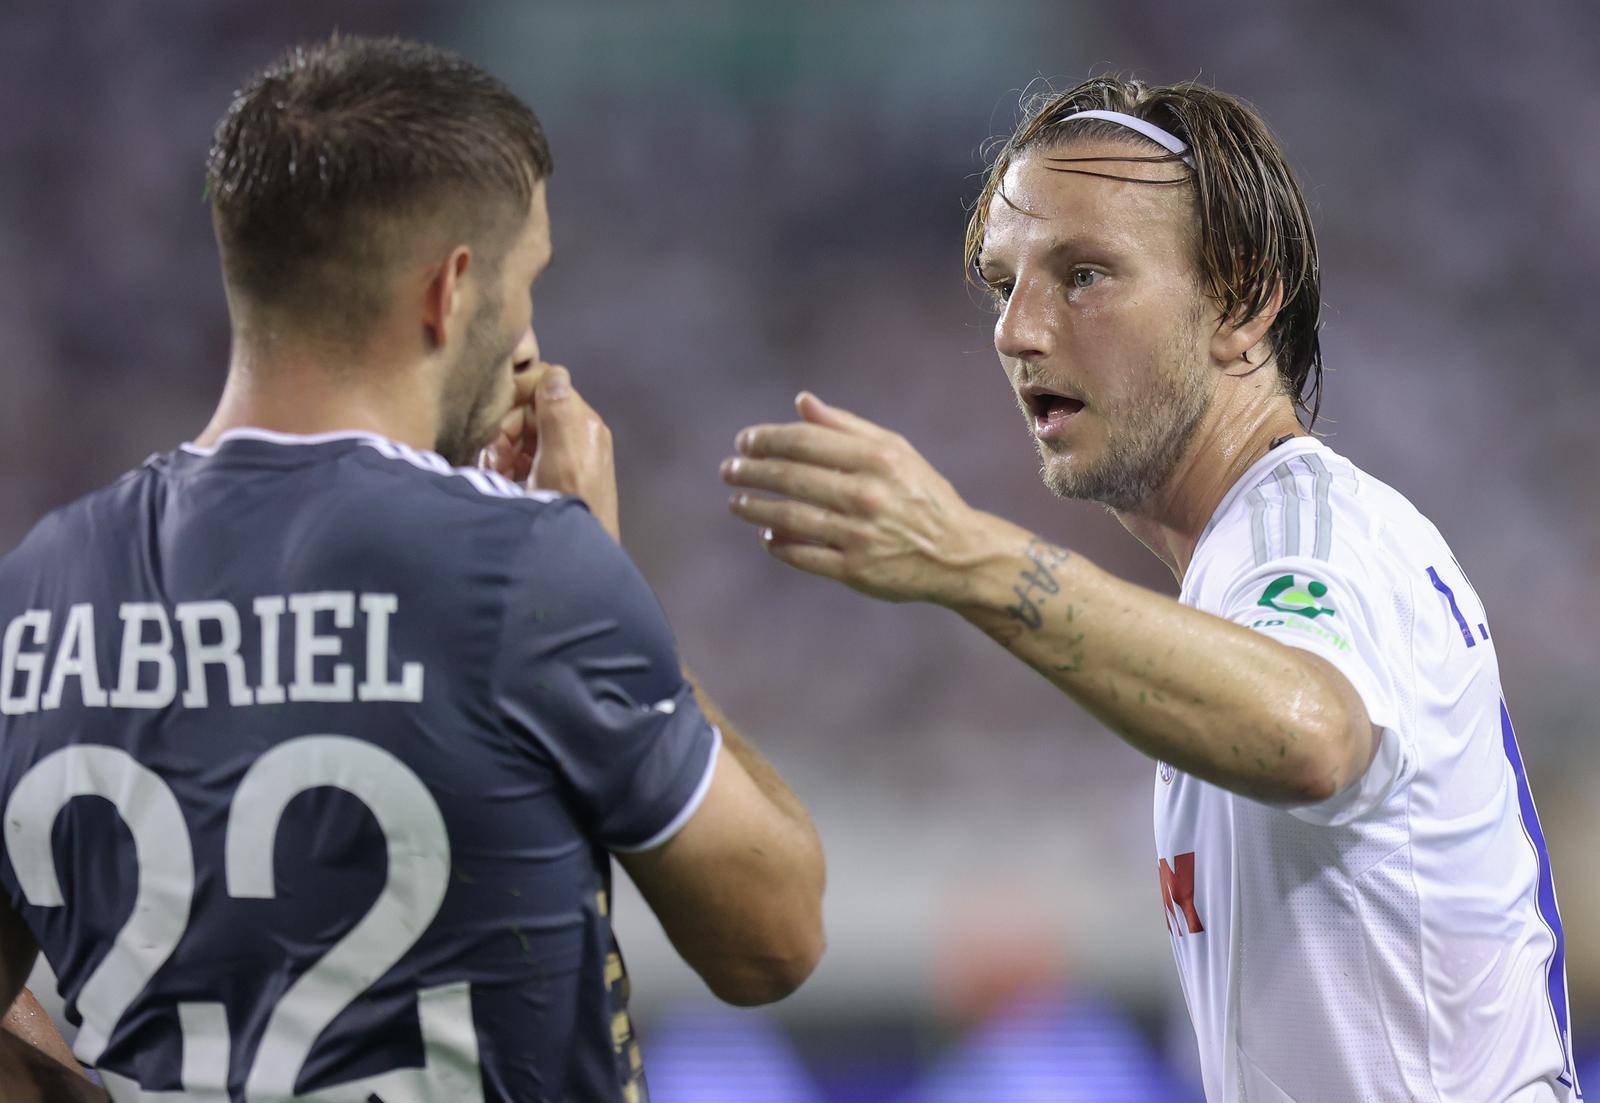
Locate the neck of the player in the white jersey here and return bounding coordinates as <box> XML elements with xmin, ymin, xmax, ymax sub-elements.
<box><xmin>1117</xmin><ymin>382</ymin><xmax>1304</xmax><ymax>583</ymax></box>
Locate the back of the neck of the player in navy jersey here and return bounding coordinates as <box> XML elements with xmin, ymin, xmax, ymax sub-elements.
<box><xmin>195</xmin><ymin>335</ymin><xmax>438</xmax><ymax>450</ymax></box>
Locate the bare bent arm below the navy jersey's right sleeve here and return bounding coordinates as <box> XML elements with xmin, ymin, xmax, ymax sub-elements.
<box><xmin>618</xmin><ymin>679</ymin><xmax>826</xmax><ymax>1007</ymax></box>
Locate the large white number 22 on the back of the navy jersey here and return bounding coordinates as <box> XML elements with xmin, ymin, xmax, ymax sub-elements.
<box><xmin>5</xmin><ymin>735</ymin><xmax>483</xmax><ymax>1103</ymax></box>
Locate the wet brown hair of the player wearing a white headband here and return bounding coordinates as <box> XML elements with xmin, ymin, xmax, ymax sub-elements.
<box><xmin>966</xmin><ymin>77</ymin><xmax>1322</xmax><ymax>424</ymax></box>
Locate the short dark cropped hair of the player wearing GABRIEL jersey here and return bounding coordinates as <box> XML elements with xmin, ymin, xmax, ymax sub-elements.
<box><xmin>205</xmin><ymin>34</ymin><xmax>552</xmax><ymax>328</ymax></box>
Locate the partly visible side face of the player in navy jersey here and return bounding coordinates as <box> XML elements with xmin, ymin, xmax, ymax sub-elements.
<box><xmin>435</xmin><ymin>181</ymin><xmax>550</xmax><ymax>466</ymax></box>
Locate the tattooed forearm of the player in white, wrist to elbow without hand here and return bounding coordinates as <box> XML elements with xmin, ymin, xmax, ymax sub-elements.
<box><xmin>952</xmin><ymin>525</ymin><xmax>1365</xmax><ymax>802</ymax></box>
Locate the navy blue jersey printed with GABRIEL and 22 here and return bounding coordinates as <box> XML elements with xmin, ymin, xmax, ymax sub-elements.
<box><xmin>0</xmin><ymin>431</ymin><xmax>718</xmax><ymax>1103</ymax></box>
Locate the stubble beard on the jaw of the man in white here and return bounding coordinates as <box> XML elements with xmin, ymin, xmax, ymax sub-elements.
<box><xmin>1035</xmin><ymin>342</ymin><xmax>1211</xmax><ymax>512</ymax></box>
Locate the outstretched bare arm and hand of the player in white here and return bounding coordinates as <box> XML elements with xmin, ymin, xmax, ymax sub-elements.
<box><xmin>723</xmin><ymin>395</ymin><xmax>1378</xmax><ymax>804</ymax></box>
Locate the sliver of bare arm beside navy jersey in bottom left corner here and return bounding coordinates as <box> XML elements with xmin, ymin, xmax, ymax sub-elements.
<box><xmin>0</xmin><ymin>900</ymin><xmax>106</xmax><ymax>1103</ymax></box>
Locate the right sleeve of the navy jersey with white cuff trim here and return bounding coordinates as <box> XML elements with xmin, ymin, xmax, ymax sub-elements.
<box><xmin>494</xmin><ymin>499</ymin><xmax>722</xmax><ymax>852</ymax></box>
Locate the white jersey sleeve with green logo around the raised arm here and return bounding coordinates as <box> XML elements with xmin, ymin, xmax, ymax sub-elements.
<box><xmin>1221</xmin><ymin>556</ymin><xmax>1418</xmax><ymax>826</ymax></box>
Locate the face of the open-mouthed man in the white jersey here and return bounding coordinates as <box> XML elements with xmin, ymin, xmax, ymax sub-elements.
<box><xmin>979</xmin><ymin>139</ymin><xmax>1214</xmax><ymax>511</ymax></box>
